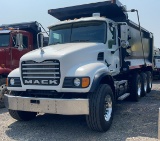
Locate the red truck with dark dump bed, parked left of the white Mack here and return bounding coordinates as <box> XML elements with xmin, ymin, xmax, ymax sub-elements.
<box><xmin>0</xmin><ymin>21</ymin><xmax>48</xmax><ymax>108</ymax></box>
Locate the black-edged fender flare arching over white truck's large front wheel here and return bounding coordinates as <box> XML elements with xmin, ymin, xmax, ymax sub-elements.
<box><xmin>89</xmin><ymin>72</ymin><xmax>115</xmax><ymax>92</ymax></box>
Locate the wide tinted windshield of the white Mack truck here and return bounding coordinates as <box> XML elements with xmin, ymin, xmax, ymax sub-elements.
<box><xmin>49</xmin><ymin>21</ymin><xmax>106</xmax><ymax>45</ymax></box>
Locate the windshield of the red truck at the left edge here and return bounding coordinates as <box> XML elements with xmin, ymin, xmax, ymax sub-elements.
<box><xmin>0</xmin><ymin>34</ymin><xmax>9</xmax><ymax>47</ymax></box>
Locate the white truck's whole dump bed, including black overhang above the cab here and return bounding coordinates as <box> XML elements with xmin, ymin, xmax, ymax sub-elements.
<box><xmin>48</xmin><ymin>0</ymin><xmax>153</xmax><ymax>68</ymax></box>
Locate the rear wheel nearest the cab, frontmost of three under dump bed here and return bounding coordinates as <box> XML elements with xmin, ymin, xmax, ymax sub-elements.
<box><xmin>130</xmin><ymin>73</ymin><xmax>142</xmax><ymax>102</ymax></box>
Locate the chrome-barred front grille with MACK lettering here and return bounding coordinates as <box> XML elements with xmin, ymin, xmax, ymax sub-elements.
<box><xmin>21</xmin><ymin>60</ymin><xmax>61</xmax><ymax>85</ymax></box>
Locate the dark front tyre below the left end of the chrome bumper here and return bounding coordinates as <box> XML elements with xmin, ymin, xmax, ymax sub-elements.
<box><xmin>8</xmin><ymin>109</ymin><xmax>37</xmax><ymax>121</ymax></box>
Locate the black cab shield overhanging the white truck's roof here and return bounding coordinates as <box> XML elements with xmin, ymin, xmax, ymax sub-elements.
<box><xmin>48</xmin><ymin>0</ymin><xmax>126</xmax><ymax>21</ymax></box>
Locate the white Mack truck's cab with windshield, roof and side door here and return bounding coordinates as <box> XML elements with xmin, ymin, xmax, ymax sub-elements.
<box><xmin>49</xmin><ymin>14</ymin><xmax>120</xmax><ymax>75</ymax></box>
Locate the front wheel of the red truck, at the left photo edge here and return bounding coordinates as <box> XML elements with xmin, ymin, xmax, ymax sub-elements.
<box><xmin>0</xmin><ymin>78</ymin><xmax>7</xmax><ymax>108</ymax></box>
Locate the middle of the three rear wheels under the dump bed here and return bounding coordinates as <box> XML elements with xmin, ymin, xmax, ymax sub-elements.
<box><xmin>140</xmin><ymin>73</ymin><xmax>147</xmax><ymax>96</ymax></box>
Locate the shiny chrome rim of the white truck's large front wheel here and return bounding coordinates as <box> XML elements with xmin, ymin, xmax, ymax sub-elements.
<box><xmin>104</xmin><ymin>95</ymin><xmax>112</xmax><ymax>121</ymax></box>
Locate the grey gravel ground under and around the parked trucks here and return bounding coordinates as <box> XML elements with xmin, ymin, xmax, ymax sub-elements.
<box><xmin>0</xmin><ymin>81</ymin><xmax>160</xmax><ymax>141</ymax></box>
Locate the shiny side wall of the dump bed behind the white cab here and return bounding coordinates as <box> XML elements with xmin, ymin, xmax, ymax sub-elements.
<box><xmin>122</xmin><ymin>20</ymin><xmax>154</xmax><ymax>69</ymax></box>
